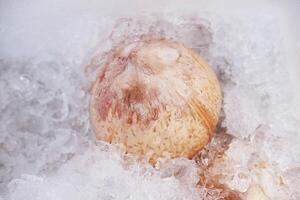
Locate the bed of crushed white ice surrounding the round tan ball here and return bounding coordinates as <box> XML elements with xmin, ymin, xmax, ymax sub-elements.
<box><xmin>0</xmin><ymin>0</ymin><xmax>300</xmax><ymax>200</ymax></box>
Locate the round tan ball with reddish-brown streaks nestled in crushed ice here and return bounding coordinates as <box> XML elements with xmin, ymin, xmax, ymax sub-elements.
<box><xmin>90</xmin><ymin>39</ymin><xmax>222</xmax><ymax>163</ymax></box>
